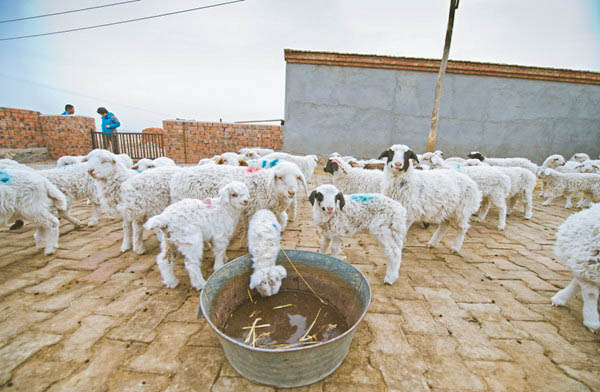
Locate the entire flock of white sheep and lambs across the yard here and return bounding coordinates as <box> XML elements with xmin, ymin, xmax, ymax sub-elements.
<box><xmin>0</xmin><ymin>144</ymin><xmax>600</xmax><ymax>331</ymax></box>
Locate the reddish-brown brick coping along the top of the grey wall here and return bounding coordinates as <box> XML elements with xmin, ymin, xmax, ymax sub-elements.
<box><xmin>284</xmin><ymin>49</ymin><xmax>600</xmax><ymax>85</ymax></box>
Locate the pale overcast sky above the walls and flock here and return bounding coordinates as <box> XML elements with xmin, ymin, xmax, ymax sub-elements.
<box><xmin>0</xmin><ymin>0</ymin><xmax>600</xmax><ymax>132</ymax></box>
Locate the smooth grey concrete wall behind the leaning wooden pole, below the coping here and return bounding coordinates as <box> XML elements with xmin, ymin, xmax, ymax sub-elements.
<box><xmin>283</xmin><ymin>63</ymin><xmax>600</xmax><ymax>163</ymax></box>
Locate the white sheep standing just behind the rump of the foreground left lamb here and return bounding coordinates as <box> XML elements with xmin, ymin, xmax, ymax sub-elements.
<box><xmin>117</xmin><ymin>166</ymin><xmax>184</xmax><ymax>255</ymax></box>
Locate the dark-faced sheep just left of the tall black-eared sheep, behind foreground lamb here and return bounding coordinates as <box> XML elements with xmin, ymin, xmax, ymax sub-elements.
<box><xmin>323</xmin><ymin>157</ymin><xmax>383</xmax><ymax>193</ymax></box>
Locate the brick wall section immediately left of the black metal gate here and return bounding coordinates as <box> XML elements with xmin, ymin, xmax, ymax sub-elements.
<box><xmin>39</xmin><ymin>115</ymin><xmax>96</xmax><ymax>159</ymax></box>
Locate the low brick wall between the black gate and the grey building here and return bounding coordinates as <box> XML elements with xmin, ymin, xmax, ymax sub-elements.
<box><xmin>152</xmin><ymin>120</ymin><xmax>283</xmax><ymax>163</ymax></box>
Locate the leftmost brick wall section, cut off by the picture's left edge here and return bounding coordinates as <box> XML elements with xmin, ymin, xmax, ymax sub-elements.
<box><xmin>0</xmin><ymin>107</ymin><xmax>45</xmax><ymax>148</ymax></box>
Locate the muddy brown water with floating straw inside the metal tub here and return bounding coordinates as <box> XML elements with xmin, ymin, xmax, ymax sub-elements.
<box><xmin>223</xmin><ymin>290</ymin><xmax>348</xmax><ymax>349</ymax></box>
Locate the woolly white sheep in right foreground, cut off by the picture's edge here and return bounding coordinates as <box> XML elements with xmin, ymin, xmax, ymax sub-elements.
<box><xmin>552</xmin><ymin>204</ymin><xmax>600</xmax><ymax>332</ymax></box>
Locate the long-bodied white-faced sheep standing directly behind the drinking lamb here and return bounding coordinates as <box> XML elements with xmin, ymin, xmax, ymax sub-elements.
<box><xmin>169</xmin><ymin>162</ymin><xmax>307</xmax><ymax>234</ymax></box>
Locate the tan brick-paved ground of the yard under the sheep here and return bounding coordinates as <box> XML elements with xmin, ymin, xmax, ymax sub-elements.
<box><xmin>0</xmin><ymin>166</ymin><xmax>600</xmax><ymax>392</ymax></box>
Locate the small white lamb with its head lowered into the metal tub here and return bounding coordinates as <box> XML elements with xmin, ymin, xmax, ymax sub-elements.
<box><xmin>248</xmin><ymin>209</ymin><xmax>287</xmax><ymax>297</ymax></box>
